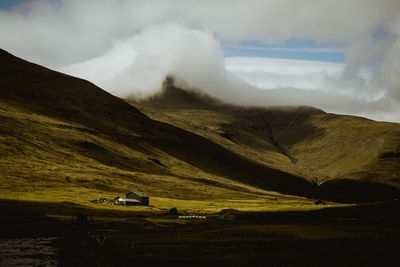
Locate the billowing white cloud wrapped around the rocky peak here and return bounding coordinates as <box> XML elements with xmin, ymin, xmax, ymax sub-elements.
<box><xmin>60</xmin><ymin>23</ymin><xmax>226</xmax><ymax>97</ymax></box>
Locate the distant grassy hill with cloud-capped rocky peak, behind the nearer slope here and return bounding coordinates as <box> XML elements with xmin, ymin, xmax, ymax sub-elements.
<box><xmin>133</xmin><ymin>81</ymin><xmax>400</xmax><ymax>203</ymax></box>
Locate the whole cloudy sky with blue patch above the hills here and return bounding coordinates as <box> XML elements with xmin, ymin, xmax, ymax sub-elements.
<box><xmin>0</xmin><ymin>0</ymin><xmax>400</xmax><ymax>122</ymax></box>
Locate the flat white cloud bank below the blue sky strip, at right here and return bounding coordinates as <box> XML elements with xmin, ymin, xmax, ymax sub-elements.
<box><xmin>225</xmin><ymin>57</ymin><xmax>400</xmax><ymax>122</ymax></box>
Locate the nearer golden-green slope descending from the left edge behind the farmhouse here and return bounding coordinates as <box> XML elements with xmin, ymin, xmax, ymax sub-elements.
<box><xmin>0</xmin><ymin>48</ymin><xmax>322</xmax><ymax>210</ymax></box>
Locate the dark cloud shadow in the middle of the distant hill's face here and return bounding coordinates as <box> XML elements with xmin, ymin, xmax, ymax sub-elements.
<box><xmin>222</xmin><ymin>106</ymin><xmax>326</xmax><ymax>163</ymax></box>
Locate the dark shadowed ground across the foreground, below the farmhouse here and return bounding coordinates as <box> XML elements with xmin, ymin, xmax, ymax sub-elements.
<box><xmin>0</xmin><ymin>200</ymin><xmax>400</xmax><ymax>266</ymax></box>
